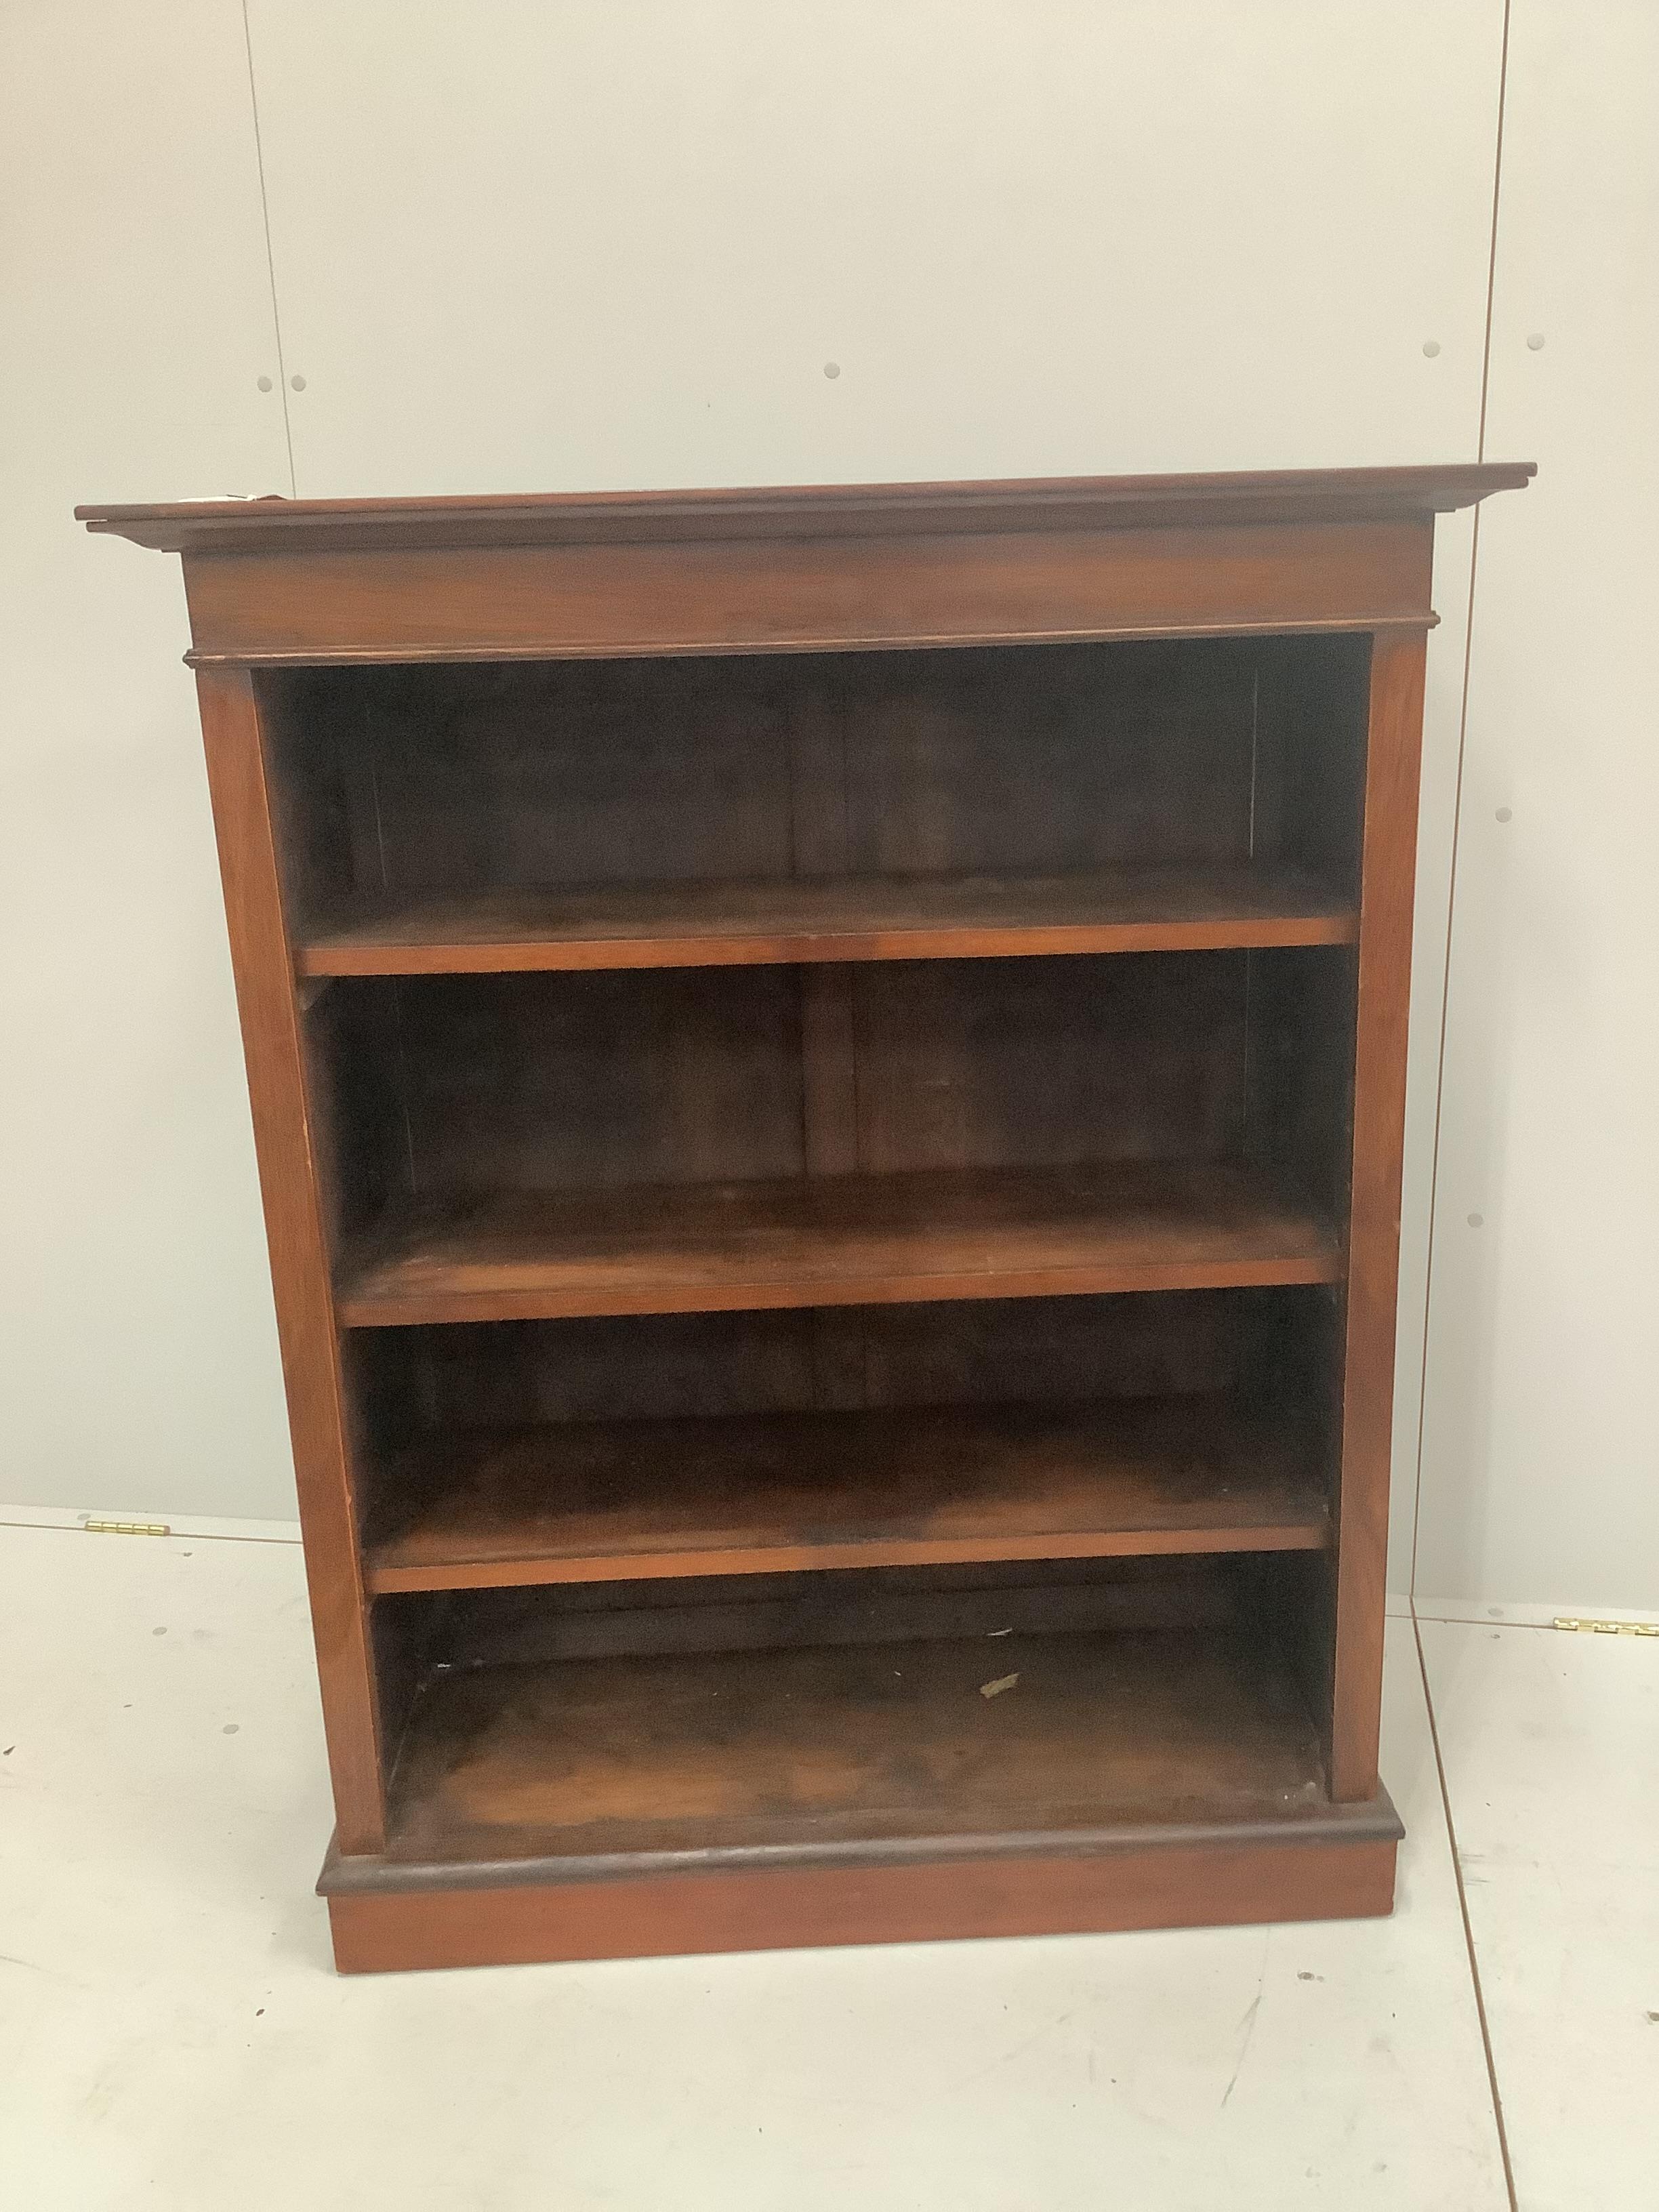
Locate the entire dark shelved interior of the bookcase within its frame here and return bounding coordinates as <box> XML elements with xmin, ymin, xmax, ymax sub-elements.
<box><xmin>261</xmin><ymin>635</ymin><xmax>1369</xmax><ymax>1856</ymax></box>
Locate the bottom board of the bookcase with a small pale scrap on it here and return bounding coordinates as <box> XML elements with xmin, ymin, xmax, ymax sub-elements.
<box><xmin>387</xmin><ymin>1628</ymin><xmax>1327</xmax><ymax>1876</ymax></box>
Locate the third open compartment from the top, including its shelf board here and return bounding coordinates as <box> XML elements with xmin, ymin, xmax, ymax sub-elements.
<box><xmin>354</xmin><ymin>1288</ymin><xmax>1338</xmax><ymax>1595</ymax></box>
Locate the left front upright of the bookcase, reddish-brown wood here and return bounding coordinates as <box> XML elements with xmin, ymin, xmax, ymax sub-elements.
<box><xmin>197</xmin><ymin>670</ymin><xmax>383</xmax><ymax>1851</ymax></box>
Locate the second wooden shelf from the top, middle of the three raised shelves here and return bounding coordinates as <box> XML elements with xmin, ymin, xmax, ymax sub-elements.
<box><xmin>338</xmin><ymin>1162</ymin><xmax>1340</xmax><ymax>1327</ymax></box>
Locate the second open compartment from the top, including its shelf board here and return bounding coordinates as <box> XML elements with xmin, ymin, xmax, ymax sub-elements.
<box><xmin>312</xmin><ymin>947</ymin><xmax>1354</xmax><ymax>1327</ymax></box>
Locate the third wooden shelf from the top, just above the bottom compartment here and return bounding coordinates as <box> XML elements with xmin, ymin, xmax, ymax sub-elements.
<box><xmin>367</xmin><ymin>1393</ymin><xmax>1330</xmax><ymax>1593</ymax></box>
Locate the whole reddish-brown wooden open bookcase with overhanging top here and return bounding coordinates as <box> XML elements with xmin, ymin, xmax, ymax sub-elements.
<box><xmin>80</xmin><ymin>467</ymin><xmax>1531</xmax><ymax>1969</ymax></box>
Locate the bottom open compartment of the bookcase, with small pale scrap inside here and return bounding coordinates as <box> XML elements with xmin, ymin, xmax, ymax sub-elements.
<box><xmin>367</xmin><ymin>1555</ymin><xmax>1353</xmax><ymax>1880</ymax></box>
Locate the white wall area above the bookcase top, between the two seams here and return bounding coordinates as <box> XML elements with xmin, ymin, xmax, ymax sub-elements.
<box><xmin>250</xmin><ymin>0</ymin><xmax>1502</xmax><ymax>495</ymax></box>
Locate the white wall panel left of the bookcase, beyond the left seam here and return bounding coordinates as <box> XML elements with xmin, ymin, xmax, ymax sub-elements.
<box><xmin>0</xmin><ymin>0</ymin><xmax>292</xmax><ymax>1515</ymax></box>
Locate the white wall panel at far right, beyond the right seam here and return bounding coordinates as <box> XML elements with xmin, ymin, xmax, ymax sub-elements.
<box><xmin>1418</xmin><ymin>0</ymin><xmax>1659</xmax><ymax>1610</ymax></box>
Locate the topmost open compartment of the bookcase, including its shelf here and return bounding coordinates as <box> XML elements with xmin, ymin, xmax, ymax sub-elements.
<box><xmin>263</xmin><ymin>635</ymin><xmax>1369</xmax><ymax>975</ymax></box>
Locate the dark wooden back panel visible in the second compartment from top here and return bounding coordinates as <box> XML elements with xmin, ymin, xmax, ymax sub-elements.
<box><xmin>314</xmin><ymin>947</ymin><xmax>1347</xmax><ymax>1225</ymax></box>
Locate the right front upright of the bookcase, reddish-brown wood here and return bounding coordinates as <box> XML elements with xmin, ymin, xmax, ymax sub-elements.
<box><xmin>1332</xmin><ymin>633</ymin><xmax>1425</xmax><ymax>1799</ymax></box>
